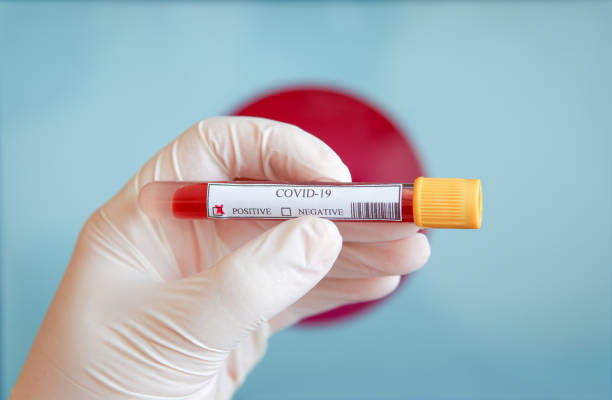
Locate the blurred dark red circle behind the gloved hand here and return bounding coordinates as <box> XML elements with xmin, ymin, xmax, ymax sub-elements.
<box><xmin>233</xmin><ymin>86</ymin><xmax>424</xmax><ymax>324</ymax></box>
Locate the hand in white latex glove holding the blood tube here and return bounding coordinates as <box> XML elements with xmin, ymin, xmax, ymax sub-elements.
<box><xmin>11</xmin><ymin>117</ymin><xmax>429</xmax><ymax>400</ymax></box>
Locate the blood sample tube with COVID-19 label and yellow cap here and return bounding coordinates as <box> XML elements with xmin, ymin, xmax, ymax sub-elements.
<box><xmin>138</xmin><ymin>177</ymin><xmax>482</xmax><ymax>229</ymax></box>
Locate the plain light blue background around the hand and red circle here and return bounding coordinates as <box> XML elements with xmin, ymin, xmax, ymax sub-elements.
<box><xmin>0</xmin><ymin>2</ymin><xmax>612</xmax><ymax>399</ymax></box>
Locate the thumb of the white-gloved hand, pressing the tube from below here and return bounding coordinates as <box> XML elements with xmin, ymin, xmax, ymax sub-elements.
<box><xmin>155</xmin><ymin>217</ymin><xmax>342</xmax><ymax>352</ymax></box>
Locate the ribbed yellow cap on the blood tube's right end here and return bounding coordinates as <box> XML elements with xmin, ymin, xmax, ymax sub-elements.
<box><xmin>412</xmin><ymin>177</ymin><xmax>482</xmax><ymax>229</ymax></box>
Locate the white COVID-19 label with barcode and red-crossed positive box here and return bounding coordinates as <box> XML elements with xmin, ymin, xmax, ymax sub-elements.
<box><xmin>206</xmin><ymin>183</ymin><xmax>402</xmax><ymax>221</ymax></box>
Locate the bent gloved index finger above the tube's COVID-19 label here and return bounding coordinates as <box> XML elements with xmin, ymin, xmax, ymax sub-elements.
<box><xmin>139</xmin><ymin>117</ymin><xmax>351</xmax><ymax>185</ymax></box>
